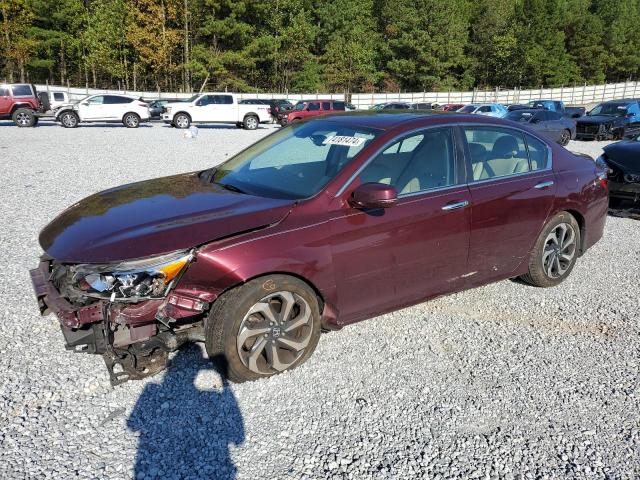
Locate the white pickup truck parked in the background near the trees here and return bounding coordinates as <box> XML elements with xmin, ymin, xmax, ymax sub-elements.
<box><xmin>162</xmin><ymin>93</ymin><xmax>271</xmax><ymax>130</ymax></box>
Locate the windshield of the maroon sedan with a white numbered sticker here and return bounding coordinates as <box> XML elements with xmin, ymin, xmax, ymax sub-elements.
<box><xmin>213</xmin><ymin>120</ymin><xmax>381</xmax><ymax>200</ymax></box>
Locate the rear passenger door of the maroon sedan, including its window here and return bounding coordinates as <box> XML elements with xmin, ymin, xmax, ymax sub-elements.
<box><xmin>461</xmin><ymin>126</ymin><xmax>556</xmax><ymax>286</ymax></box>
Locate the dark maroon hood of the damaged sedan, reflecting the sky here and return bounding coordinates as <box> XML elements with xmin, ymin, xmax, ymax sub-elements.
<box><xmin>40</xmin><ymin>173</ymin><xmax>293</xmax><ymax>263</ymax></box>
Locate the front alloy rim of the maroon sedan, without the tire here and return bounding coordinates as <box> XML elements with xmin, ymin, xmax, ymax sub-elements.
<box><xmin>236</xmin><ymin>291</ymin><xmax>313</xmax><ymax>375</ymax></box>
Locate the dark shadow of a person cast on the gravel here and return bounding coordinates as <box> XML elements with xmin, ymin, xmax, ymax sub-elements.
<box><xmin>127</xmin><ymin>345</ymin><xmax>244</xmax><ymax>480</ymax></box>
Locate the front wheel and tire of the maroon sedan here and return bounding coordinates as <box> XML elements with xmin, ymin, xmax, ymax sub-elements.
<box><xmin>205</xmin><ymin>275</ymin><xmax>320</xmax><ymax>382</ymax></box>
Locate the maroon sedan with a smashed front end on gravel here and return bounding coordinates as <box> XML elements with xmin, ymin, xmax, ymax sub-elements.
<box><xmin>31</xmin><ymin>113</ymin><xmax>607</xmax><ymax>384</ymax></box>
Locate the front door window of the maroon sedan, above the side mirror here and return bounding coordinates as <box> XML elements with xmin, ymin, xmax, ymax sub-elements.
<box><xmin>360</xmin><ymin>128</ymin><xmax>456</xmax><ymax>195</ymax></box>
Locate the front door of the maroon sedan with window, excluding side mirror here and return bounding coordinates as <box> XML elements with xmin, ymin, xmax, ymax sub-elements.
<box><xmin>329</xmin><ymin>127</ymin><xmax>470</xmax><ymax>323</ymax></box>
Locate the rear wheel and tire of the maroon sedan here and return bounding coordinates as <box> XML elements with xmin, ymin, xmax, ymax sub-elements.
<box><xmin>520</xmin><ymin>212</ymin><xmax>581</xmax><ymax>288</ymax></box>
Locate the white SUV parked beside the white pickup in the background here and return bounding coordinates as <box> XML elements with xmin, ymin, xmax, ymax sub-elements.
<box><xmin>55</xmin><ymin>95</ymin><xmax>149</xmax><ymax>128</ymax></box>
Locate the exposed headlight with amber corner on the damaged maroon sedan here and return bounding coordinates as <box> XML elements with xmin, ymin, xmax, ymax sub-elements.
<box><xmin>70</xmin><ymin>251</ymin><xmax>193</xmax><ymax>301</ymax></box>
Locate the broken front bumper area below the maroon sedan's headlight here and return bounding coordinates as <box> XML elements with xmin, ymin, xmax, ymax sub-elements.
<box><xmin>29</xmin><ymin>260</ymin><xmax>208</xmax><ymax>385</ymax></box>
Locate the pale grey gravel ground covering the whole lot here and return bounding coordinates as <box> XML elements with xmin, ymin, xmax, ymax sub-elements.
<box><xmin>0</xmin><ymin>124</ymin><xmax>640</xmax><ymax>479</ymax></box>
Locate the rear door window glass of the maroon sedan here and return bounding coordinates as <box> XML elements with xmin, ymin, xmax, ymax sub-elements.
<box><xmin>464</xmin><ymin>127</ymin><xmax>529</xmax><ymax>181</ymax></box>
